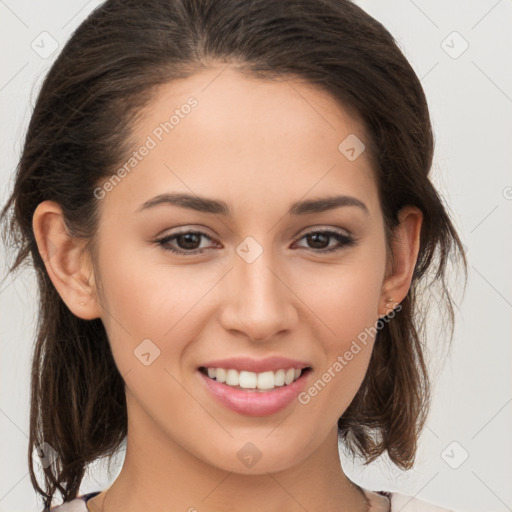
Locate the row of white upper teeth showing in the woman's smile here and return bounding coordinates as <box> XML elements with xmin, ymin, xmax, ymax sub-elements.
<box><xmin>201</xmin><ymin>368</ymin><xmax>302</xmax><ymax>389</ymax></box>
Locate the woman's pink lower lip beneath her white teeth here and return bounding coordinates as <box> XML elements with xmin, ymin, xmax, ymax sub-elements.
<box><xmin>198</xmin><ymin>370</ymin><xmax>311</xmax><ymax>416</ymax></box>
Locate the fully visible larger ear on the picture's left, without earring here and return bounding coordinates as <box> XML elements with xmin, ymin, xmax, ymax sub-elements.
<box><xmin>32</xmin><ymin>201</ymin><xmax>101</xmax><ymax>320</ymax></box>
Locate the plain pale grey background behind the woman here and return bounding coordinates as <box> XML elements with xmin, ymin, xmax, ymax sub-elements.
<box><xmin>0</xmin><ymin>0</ymin><xmax>512</xmax><ymax>512</ymax></box>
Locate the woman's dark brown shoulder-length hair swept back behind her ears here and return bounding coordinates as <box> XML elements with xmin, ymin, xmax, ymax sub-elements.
<box><xmin>1</xmin><ymin>0</ymin><xmax>467</xmax><ymax>507</ymax></box>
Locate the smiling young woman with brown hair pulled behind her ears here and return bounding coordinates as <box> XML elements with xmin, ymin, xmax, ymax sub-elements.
<box><xmin>3</xmin><ymin>0</ymin><xmax>466</xmax><ymax>512</ymax></box>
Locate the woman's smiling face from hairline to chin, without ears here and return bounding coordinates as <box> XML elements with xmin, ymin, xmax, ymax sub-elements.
<box><xmin>92</xmin><ymin>67</ymin><xmax>386</xmax><ymax>473</ymax></box>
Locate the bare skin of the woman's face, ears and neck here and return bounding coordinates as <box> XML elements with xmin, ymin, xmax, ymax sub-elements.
<box><xmin>33</xmin><ymin>65</ymin><xmax>422</xmax><ymax>512</ymax></box>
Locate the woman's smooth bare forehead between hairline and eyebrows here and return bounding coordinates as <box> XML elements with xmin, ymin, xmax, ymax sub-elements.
<box><xmin>101</xmin><ymin>66</ymin><xmax>377</xmax><ymax>220</ymax></box>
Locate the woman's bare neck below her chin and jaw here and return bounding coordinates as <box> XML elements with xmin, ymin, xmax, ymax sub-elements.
<box><xmin>88</xmin><ymin>400</ymin><xmax>368</xmax><ymax>512</ymax></box>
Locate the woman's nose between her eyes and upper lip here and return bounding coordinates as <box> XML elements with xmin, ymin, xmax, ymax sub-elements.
<box><xmin>221</xmin><ymin>245</ymin><xmax>298</xmax><ymax>341</ymax></box>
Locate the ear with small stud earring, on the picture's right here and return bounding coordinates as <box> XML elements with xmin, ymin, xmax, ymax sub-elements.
<box><xmin>379</xmin><ymin>206</ymin><xmax>423</xmax><ymax>316</ymax></box>
